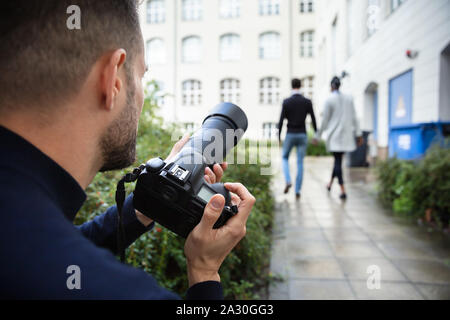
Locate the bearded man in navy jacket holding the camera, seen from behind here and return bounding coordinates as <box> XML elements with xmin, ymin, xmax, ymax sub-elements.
<box><xmin>0</xmin><ymin>0</ymin><xmax>255</xmax><ymax>299</ymax></box>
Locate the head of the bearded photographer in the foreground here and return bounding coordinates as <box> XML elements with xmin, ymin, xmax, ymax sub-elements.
<box><xmin>0</xmin><ymin>0</ymin><xmax>145</xmax><ymax>170</ymax></box>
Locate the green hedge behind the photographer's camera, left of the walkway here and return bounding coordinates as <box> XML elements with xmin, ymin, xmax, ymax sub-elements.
<box><xmin>75</xmin><ymin>83</ymin><xmax>273</xmax><ymax>299</ymax></box>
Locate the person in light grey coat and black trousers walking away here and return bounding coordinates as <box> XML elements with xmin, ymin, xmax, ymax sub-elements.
<box><xmin>316</xmin><ymin>77</ymin><xmax>362</xmax><ymax>200</ymax></box>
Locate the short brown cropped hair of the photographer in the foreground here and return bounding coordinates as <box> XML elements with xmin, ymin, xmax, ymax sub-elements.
<box><xmin>0</xmin><ymin>0</ymin><xmax>142</xmax><ymax>112</ymax></box>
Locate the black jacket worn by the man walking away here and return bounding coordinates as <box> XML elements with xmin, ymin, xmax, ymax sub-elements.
<box><xmin>278</xmin><ymin>94</ymin><xmax>317</xmax><ymax>138</ymax></box>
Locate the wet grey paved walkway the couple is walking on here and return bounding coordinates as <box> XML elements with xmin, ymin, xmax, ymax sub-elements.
<box><xmin>270</xmin><ymin>157</ymin><xmax>450</xmax><ymax>300</ymax></box>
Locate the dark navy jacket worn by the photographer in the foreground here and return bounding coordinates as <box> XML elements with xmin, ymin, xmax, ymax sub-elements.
<box><xmin>0</xmin><ymin>126</ymin><xmax>222</xmax><ymax>299</ymax></box>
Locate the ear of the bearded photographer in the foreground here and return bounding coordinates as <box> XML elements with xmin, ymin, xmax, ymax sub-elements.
<box><xmin>101</xmin><ymin>49</ymin><xmax>127</xmax><ymax>110</ymax></box>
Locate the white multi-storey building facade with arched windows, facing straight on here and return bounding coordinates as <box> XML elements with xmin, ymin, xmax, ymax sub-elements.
<box><xmin>141</xmin><ymin>0</ymin><xmax>317</xmax><ymax>139</ymax></box>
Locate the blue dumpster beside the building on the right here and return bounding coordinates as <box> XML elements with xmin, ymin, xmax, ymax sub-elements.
<box><xmin>389</xmin><ymin>122</ymin><xmax>450</xmax><ymax>160</ymax></box>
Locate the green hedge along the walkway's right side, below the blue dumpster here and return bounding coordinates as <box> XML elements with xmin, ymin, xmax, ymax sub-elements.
<box><xmin>376</xmin><ymin>142</ymin><xmax>450</xmax><ymax>228</ymax></box>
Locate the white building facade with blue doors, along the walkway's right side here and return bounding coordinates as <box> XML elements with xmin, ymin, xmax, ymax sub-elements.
<box><xmin>316</xmin><ymin>0</ymin><xmax>450</xmax><ymax>158</ymax></box>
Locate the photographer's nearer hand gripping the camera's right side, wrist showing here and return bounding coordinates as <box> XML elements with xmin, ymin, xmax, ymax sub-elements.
<box><xmin>184</xmin><ymin>183</ymin><xmax>256</xmax><ymax>287</ymax></box>
